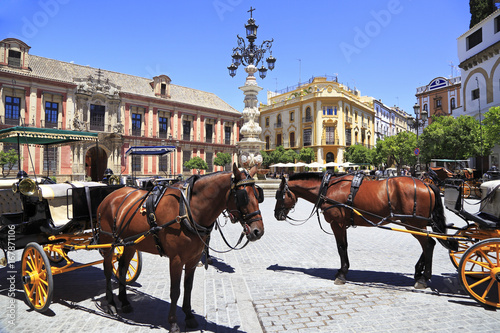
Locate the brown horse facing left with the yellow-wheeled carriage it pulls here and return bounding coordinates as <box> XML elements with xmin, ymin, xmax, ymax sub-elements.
<box><xmin>275</xmin><ymin>173</ymin><xmax>500</xmax><ymax>308</ymax></box>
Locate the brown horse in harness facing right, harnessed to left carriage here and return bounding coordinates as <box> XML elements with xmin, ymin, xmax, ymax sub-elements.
<box><xmin>97</xmin><ymin>164</ymin><xmax>264</xmax><ymax>332</ymax></box>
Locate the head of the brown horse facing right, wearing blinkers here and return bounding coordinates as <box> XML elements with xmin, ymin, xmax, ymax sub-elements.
<box><xmin>227</xmin><ymin>164</ymin><xmax>264</xmax><ymax>241</ymax></box>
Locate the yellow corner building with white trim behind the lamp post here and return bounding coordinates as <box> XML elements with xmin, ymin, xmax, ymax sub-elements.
<box><xmin>260</xmin><ymin>77</ymin><xmax>375</xmax><ymax>163</ymax></box>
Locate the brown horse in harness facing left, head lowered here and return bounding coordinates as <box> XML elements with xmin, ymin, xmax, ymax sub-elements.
<box><xmin>274</xmin><ymin>173</ymin><xmax>458</xmax><ymax>288</ymax></box>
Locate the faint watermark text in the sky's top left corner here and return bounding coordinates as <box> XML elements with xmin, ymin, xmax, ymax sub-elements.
<box><xmin>10</xmin><ymin>0</ymin><xmax>71</xmax><ymax>40</ymax></box>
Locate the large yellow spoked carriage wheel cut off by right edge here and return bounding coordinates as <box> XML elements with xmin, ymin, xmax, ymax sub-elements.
<box><xmin>458</xmin><ymin>238</ymin><xmax>500</xmax><ymax>308</ymax></box>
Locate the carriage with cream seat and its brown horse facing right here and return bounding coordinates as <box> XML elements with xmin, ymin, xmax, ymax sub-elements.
<box><xmin>0</xmin><ymin>128</ymin><xmax>264</xmax><ymax>332</ymax></box>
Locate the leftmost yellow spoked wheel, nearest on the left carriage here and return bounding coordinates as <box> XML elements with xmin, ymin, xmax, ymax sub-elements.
<box><xmin>21</xmin><ymin>243</ymin><xmax>54</xmax><ymax>312</ymax></box>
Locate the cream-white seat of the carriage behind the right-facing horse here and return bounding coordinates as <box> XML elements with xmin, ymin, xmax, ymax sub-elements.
<box><xmin>38</xmin><ymin>182</ymin><xmax>107</xmax><ymax>228</ymax></box>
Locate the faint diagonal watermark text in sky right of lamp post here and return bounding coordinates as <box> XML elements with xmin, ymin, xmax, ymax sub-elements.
<box><xmin>339</xmin><ymin>0</ymin><xmax>403</xmax><ymax>64</ymax></box>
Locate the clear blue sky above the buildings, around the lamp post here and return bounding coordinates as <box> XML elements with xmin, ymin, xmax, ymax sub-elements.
<box><xmin>0</xmin><ymin>0</ymin><xmax>476</xmax><ymax>114</ymax></box>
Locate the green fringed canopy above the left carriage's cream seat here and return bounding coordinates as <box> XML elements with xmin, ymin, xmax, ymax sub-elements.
<box><xmin>0</xmin><ymin>126</ymin><xmax>97</xmax><ymax>145</ymax></box>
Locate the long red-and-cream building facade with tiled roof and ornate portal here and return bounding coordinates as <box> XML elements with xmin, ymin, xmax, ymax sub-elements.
<box><xmin>0</xmin><ymin>38</ymin><xmax>241</xmax><ymax>180</ymax></box>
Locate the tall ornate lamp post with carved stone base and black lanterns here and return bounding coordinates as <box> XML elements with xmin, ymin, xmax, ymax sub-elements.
<box><xmin>227</xmin><ymin>7</ymin><xmax>276</xmax><ymax>168</ymax></box>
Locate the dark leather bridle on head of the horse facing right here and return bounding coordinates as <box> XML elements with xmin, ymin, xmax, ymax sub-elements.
<box><xmin>228</xmin><ymin>170</ymin><xmax>264</xmax><ymax>234</ymax></box>
